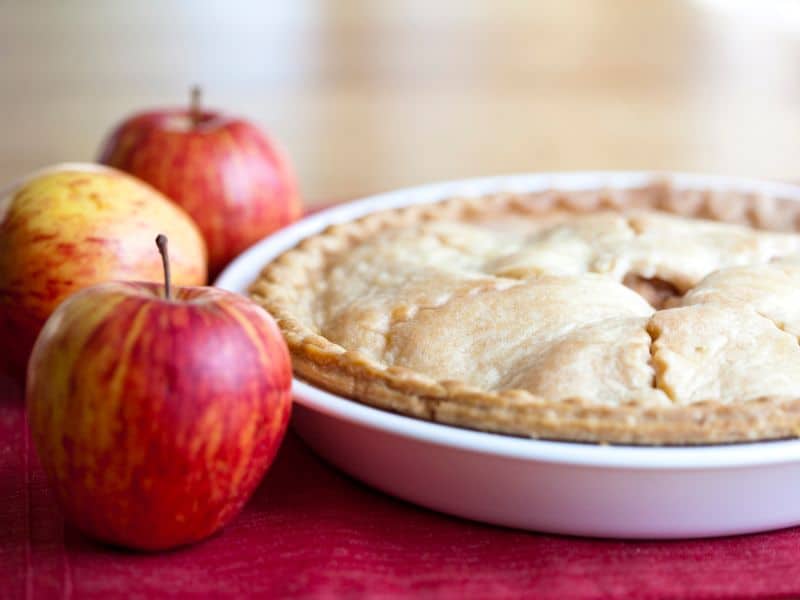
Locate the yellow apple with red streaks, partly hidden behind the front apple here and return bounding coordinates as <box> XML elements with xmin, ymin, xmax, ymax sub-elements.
<box><xmin>0</xmin><ymin>163</ymin><xmax>207</xmax><ymax>379</ymax></box>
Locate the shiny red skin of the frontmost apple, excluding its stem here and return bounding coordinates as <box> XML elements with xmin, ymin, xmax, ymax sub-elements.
<box><xmin>26</xmin><ymin>282</ymin><xmax>292</xmax><ymax>550</ymax></box>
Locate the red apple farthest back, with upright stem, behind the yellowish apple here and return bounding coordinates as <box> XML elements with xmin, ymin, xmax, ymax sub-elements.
<box><xmin>100</xmin><ymin>88</ymin><xmax>302</xmax><ymax>280</ymax></box>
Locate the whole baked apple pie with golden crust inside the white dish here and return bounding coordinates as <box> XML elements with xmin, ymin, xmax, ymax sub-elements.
<box><xmin>250</xmin><ymin>182</ymin><xmax>800</xmax><ymax>445</ymax></box>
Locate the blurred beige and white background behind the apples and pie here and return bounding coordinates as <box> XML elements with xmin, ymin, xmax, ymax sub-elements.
<box><xmin>0</xmin><ymin>0</ymin><xmax>800</xmax><ymax>204</ymax></box>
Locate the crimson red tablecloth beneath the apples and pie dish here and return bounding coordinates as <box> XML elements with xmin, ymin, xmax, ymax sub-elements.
<box><xmin>0</xmin><ymin>372</ymin><xmax>800</xmax><ymax>600</ymax></box>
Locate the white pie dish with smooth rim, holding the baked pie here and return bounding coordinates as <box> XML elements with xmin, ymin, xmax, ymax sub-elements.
<box><xmin>216</xmin><ymin>173</ymin><xmax>800</xmax><ymax>538</ymax></box>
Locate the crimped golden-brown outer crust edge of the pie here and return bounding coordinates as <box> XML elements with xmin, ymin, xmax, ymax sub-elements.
<box><xmin>249</xmin><ymin>182</ymin><xmax>800</xmax><ymax>445</ymax></box>
